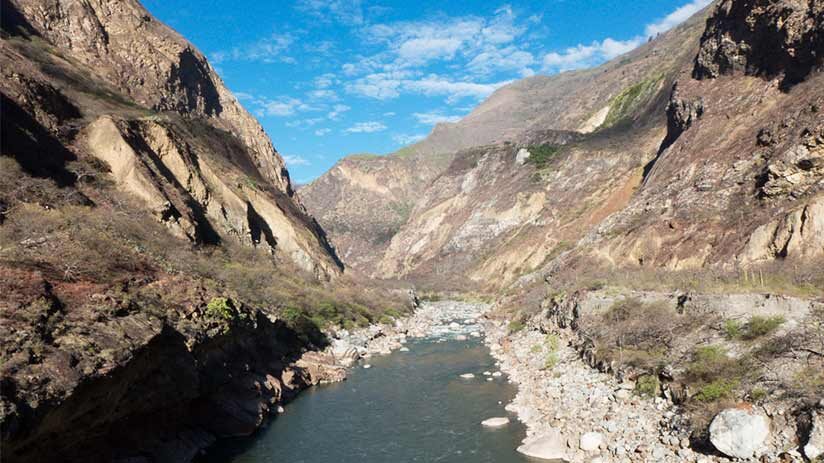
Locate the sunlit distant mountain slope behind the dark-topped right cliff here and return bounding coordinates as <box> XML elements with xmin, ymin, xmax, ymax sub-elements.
<box><xmin>300</xmin><ymin>6</ymin><xmax>706</xmax><ymax>286</ymax></box>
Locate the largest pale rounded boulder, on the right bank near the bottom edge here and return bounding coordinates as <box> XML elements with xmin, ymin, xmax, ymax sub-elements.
<box><xmin>710</xmin><ymin>408</ymin><xmax>770</xmax><ymax>458</ymax></box>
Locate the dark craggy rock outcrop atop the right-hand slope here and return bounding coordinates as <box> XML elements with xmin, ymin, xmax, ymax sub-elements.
<box><xmin>693</xmin><ymin>0</ymin><xmax>824</xmax><ymax>84</ymax></box>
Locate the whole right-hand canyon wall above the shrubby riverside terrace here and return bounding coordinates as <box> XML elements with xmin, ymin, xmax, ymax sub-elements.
<box><xmin>301</xmin><ymin>1</ymin><xmax>824</xmax><ymax>289</ymax></box>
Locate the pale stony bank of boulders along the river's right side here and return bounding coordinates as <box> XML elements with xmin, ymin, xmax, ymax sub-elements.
<box><xmin>485</xmin><ymin>300</ymin><xmax>824</xmax><ymax>463</ymax></box>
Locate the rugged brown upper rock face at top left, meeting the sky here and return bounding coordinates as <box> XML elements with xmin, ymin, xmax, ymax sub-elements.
<box><xmin>8</xmin><ymin>0</ymin><xmax>291</xmax><ymax>194</ymax></box>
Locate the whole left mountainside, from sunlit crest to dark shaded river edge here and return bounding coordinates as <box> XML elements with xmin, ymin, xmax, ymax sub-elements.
<box><xmin>0</xmin><ymin>0</ymin><xmax>410</xmax><ymax>462</ymax></box>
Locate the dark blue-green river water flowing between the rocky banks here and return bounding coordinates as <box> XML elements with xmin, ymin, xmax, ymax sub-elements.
<box><xmin>202</xmin><ymin>339</ymin><xmax>527</xmax><ymax>463</ymax></box>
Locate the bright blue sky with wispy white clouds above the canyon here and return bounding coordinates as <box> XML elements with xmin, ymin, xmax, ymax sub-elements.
<box><xmin>143</xmin><ymin>0</ymin><xmax>710</xmax><ymax>183</ymax></box>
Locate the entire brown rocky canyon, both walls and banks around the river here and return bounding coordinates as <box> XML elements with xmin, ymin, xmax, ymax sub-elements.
<box><xmin>0</xmin><ymin>0</ymin><xmax>824</xmax><ymax>462</ymax></box>
